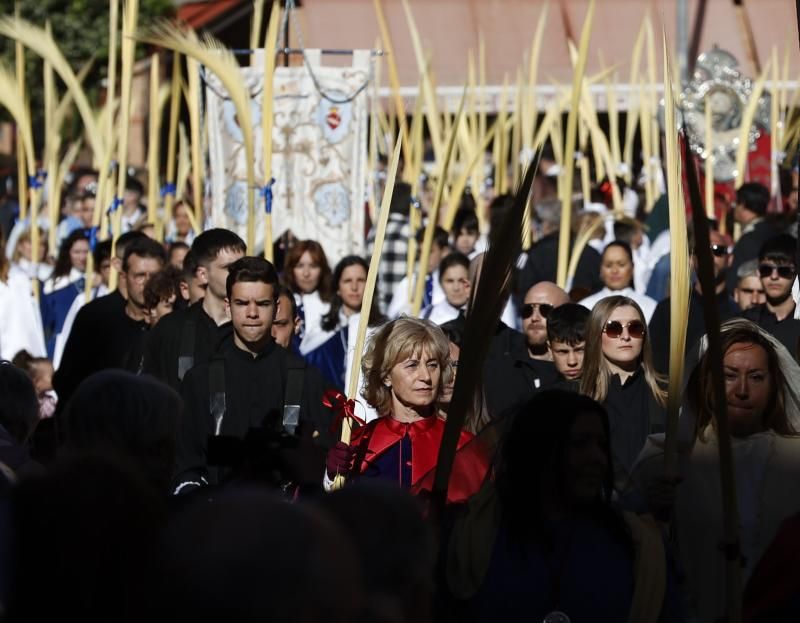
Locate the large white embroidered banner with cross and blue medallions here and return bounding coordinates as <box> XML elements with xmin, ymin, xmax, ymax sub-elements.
<box><xmin>205</xmin><ymin>50</ymin><xmax>372</xmax><ymax>265</ymax></box>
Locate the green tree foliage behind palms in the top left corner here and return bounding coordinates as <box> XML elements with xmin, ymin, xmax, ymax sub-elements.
<box><xmin>0</xmin><ymin>0</ymin><xmax>175</xmax><ymax>149</ymax></box>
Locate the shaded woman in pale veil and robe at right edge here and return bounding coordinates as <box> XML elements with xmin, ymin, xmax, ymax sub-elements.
<box><xmin>634</xmin><ymin>319</ymin><xmax>800</xmax><ymax>621</ymax></box>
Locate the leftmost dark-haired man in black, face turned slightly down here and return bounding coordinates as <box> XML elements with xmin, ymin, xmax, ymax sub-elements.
<box><xmin>53</xmin><ymin>234</ymin><xmax>165</xmax><ymax>407</ymax></box>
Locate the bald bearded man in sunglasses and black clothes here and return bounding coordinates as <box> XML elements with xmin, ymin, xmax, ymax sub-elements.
<box><xmin>485</xmin><ymin>281</ymin><xmax>569</xmax><ymax>417</ymax></box>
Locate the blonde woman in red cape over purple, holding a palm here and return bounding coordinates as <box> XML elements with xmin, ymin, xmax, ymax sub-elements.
<box><xmin>326</xmin><ymin>317</ymin><xmax>487</xmax><ymax>502</ymax></box>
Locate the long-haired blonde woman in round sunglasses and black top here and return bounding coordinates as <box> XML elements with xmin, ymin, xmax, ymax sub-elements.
<box><xmin>581</xmin><ymin>296</ymin><xmax>667</xmax><ymax>494</ymax></box>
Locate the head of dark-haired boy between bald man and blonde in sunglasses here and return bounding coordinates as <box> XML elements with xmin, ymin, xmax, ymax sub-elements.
<box><xmin>547</xmin><ymin>303</ymin><xmax>591</xmax><ymax>391</ymax></box>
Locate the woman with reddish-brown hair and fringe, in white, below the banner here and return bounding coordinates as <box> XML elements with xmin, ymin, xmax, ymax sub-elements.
<box><xmin>283</xmin><ymin>240</ymin><xmax>332</xmax><ymax>350</ymax></box>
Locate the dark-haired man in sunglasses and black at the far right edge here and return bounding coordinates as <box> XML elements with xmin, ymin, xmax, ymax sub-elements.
<box><xmin>742</xmin><ymin>234</ymin><xmax>800</xmax><ymax>359</ymax></box>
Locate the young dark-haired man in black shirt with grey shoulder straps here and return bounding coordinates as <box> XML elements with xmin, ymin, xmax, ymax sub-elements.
<box><xmin>175</xmin><ymin>257</ymin><xmax>330</xmax><ymax>493</ymax></box>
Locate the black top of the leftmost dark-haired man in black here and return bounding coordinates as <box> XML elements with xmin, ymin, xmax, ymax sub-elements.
<box><xmin>53</xmin><ymin>290</ymin><xmax>149</xmax><ymax>410</ymax></box>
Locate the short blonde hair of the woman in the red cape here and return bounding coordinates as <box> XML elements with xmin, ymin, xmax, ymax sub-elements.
<box><xmin>361</xmin><ymin>316</ymin><xmax>453</xmax><ymax>416</ymax></box>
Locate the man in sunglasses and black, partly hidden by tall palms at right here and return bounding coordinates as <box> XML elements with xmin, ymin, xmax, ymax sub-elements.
<box><xmin>647</xmin><ymin>230</ymin><xmax>739</xmax><ymax>375</ymax></box>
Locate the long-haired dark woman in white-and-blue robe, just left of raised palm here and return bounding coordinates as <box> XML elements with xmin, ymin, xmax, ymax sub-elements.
<box><xmin>299</xmin><ymin>255</ymin><xmax>385</xmax><ymax>390</ymax></box>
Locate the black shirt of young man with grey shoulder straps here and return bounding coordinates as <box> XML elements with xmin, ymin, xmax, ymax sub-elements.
<box><xmin>175</xmin><ymin>336</ymin><xmax>332</xmax><ymax>488</ymax></box>
